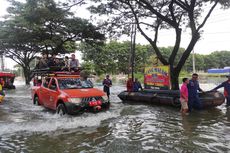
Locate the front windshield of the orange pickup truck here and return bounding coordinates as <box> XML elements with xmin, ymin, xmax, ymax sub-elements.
<box><xmin>58</xmin><ymin>78</ymin><xmax>93</xmax><ymax>89</ymax></box>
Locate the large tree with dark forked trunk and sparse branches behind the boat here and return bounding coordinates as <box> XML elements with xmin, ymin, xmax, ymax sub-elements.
<box><xmin>90</xmin><ymin>0</ymin><xmax>230</xmax><ymax>90</ymax></box>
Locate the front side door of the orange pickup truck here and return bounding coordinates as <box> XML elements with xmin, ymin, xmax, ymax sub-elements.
<box><xmin>48</xmin><ymin>78</ymin><xmax>58</xmax><ymax>110</ymax></box>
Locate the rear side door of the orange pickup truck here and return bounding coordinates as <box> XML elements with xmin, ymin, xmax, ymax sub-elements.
<box><xmin>39</xmin><ymin>78</ymin><xmax>50</xmax><ymax>106</ymax></box>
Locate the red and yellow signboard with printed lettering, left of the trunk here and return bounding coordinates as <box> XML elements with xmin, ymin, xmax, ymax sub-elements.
<box><xmin>144</xmin><ymin>66</ymin><xmax>170</xmax><ymax>90</ymax></box>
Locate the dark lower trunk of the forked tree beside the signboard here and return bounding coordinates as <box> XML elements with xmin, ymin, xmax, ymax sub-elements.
<box><xmin>170</xmin><ymin>68</ymin><xmax>180</xmax><ymax>90</ymax></box>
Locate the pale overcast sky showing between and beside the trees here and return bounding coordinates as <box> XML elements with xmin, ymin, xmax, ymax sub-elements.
<box><xmin>0</xmin><ymin>0</ymin><xmax>230</xmax><ymax>67</ymax></box>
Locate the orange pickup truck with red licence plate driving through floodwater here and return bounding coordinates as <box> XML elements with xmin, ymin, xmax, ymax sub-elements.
<box><xmin>32</xmin><ymin>73</ymin><xmax>109</xmax><ymax>115</ymax></box>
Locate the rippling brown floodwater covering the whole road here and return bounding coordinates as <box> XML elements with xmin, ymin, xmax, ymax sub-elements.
<box><xmin>0</xmin><ymin>79</ymin><xmax>230</xmax><ymax>153</ymax></box>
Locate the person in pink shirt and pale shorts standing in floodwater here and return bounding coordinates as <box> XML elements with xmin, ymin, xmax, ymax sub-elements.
<box><xmin>180</xmin><ymin>78</ymin><xmax>189</xmax><ymax>113</ymax></box>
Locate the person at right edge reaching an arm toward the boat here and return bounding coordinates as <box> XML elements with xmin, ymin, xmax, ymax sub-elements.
<box><xmin>211</xmin><ymin>74</ymin><xmax>230</xmax><ymax>107</ymax></box>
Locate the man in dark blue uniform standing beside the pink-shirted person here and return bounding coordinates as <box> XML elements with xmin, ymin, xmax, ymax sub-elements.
<box><xmin>187</xmin><ymin>73</ymin><xmax>204</xmax><ymax>112</ymax></box>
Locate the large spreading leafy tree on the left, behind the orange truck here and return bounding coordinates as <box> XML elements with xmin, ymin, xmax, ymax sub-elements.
<box><xmin>0</xmin><ymin>0</ymin><xmax>104</xmax><ymax>84</ymax></box>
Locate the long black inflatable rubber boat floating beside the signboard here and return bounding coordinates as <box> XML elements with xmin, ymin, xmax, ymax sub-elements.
<box><xmin>118</xmin><ymin>90</ymin><xmax>225</xmax><ymax>108</ymax></box>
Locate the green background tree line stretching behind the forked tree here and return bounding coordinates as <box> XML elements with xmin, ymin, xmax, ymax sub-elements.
<box><xmin>79</xmin><ymin>41</ymin><xmax>230</xmax><ymax>76</ymax></box>
